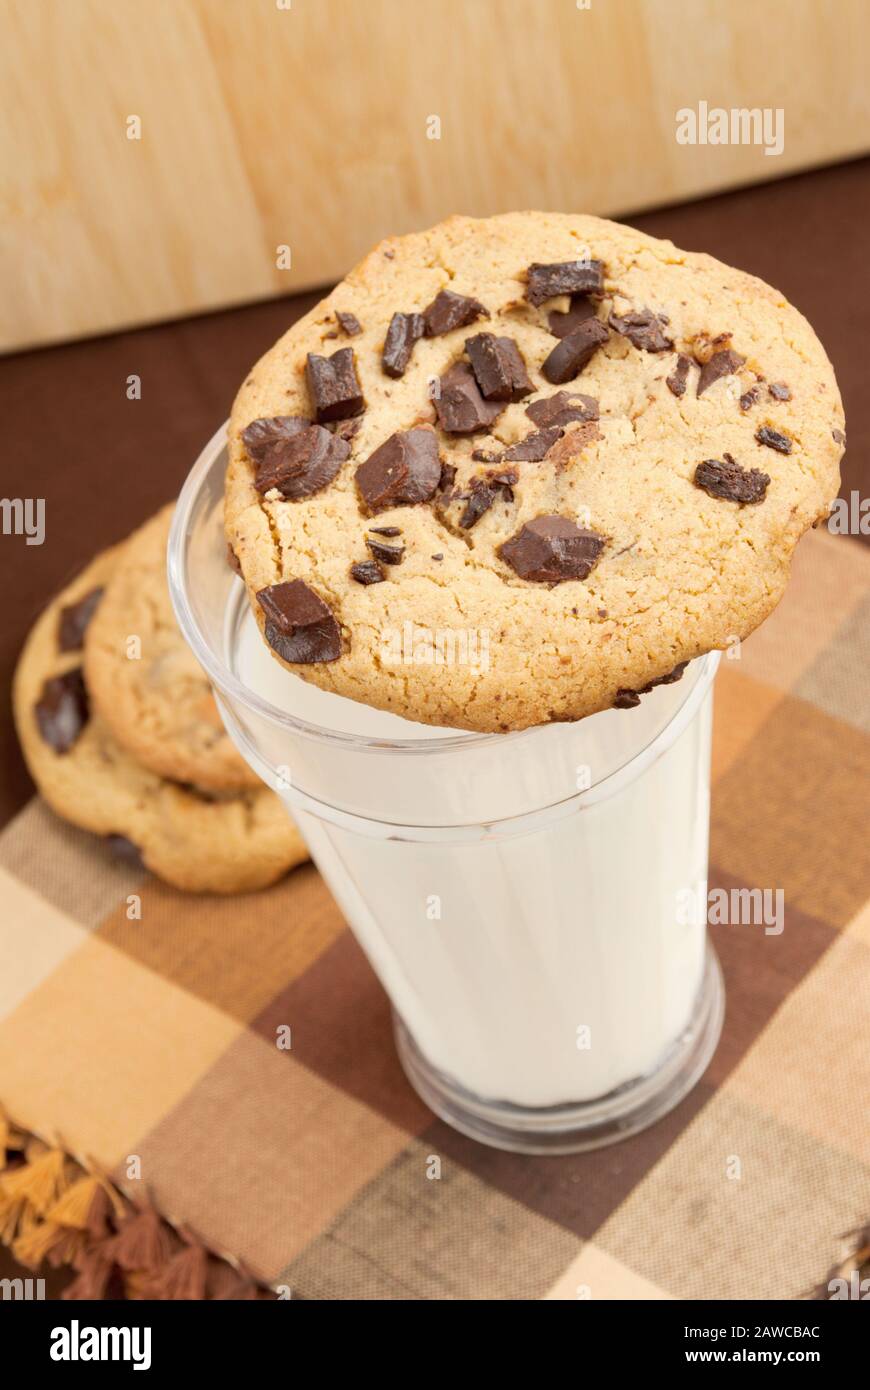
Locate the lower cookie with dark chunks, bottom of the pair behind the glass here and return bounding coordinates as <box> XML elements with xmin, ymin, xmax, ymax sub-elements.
<box><xmin>13</xmin><ymin>546</ymin><xmax>307</xmax><ymax>892</ymax></box>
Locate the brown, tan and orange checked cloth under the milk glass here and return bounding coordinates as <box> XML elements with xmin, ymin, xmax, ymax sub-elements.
<box><xmin>0</xmin><ymin>531</ymin><xmax>870</xmax><ymax>1300</ymax></box>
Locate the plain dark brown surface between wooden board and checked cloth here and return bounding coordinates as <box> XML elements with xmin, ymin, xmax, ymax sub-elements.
<box><xmin>0</xmin><ymin>160</ymin><xmax>870</xmax><ymax>1295</ymax></box>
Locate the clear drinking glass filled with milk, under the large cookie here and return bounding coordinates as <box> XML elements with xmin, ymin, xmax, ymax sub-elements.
<box><xmin>168</xmin><ymin>430</ymin><xmax>723</xmax><ymax>1154</ymax></box>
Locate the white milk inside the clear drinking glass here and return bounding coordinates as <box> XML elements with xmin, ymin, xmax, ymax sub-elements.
<box><xmin>232</xmin><ymin>614</ymin><xmax>712</xmax><ymax>1106</ymax></box>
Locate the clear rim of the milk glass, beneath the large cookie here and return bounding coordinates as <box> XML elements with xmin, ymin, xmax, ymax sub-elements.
<box><xmin>167</xmin><ymin>420</ymin><xmax>720</xmax><ymax>762</ymax></box>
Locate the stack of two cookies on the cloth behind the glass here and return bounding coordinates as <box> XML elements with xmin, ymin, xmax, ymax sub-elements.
<box><xmin>14</xmin><ymin>506</ymin><xmax>307</xmax><ymax>892</ymax></box>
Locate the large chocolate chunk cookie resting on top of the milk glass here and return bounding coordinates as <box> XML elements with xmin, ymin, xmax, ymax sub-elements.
<box><xmin>225</xmin><ymin>213</ymin><xmax>844</xmax><ymax>731</ymax></box>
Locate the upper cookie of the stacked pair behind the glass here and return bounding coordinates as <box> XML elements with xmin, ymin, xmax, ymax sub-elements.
<box><xmin>85</xmin><ymin>506</ymin><xmax>260</xmax><ymax>791</ymax></box>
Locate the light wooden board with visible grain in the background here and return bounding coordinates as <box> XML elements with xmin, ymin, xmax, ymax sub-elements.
<box><xmin>0</xmin><ymin>0</ymin><xmax>870</xmax><ymax>350</ymax></box>
